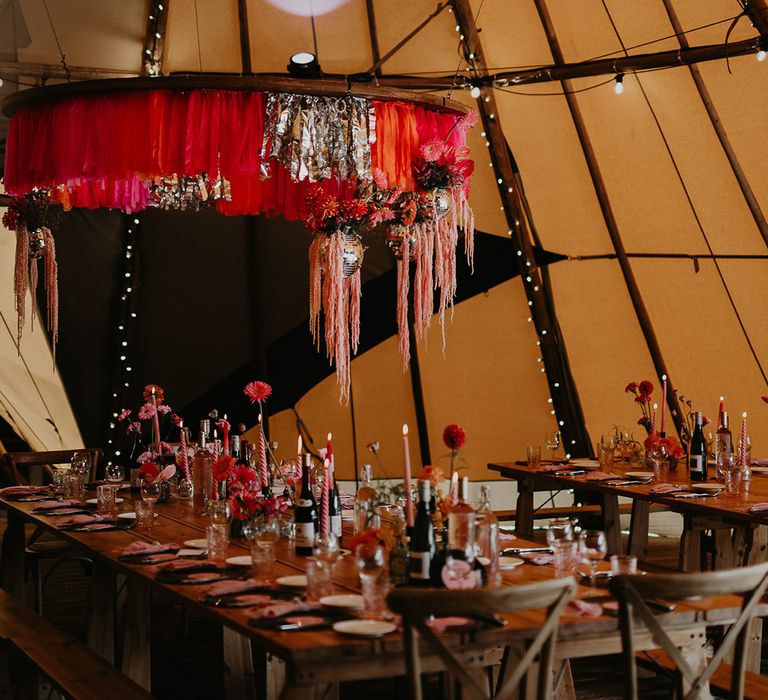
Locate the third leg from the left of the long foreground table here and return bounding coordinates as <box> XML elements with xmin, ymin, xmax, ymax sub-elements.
<box><xmin>120</xmin><ymin>576</ymin><xmax>152</xmax><ymax>690</ymax></box>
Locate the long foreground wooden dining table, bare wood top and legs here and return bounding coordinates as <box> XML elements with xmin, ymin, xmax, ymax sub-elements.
<box><xmin>0</xmin><ymin>490</ymin><xmax>768</xmax><ymax>698</ymax></box>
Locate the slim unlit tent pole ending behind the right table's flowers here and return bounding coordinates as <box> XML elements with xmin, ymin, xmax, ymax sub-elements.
<box><xmin>534</xmin><ymin>0</ymin><xmax>683</xmax><ymax>434</ymax></box>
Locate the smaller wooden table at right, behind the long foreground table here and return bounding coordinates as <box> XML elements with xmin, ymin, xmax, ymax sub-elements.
<box><xmin>488</xmin><ymin>462</ymin><xmax>768</xmax><ymax>570</ymax></box>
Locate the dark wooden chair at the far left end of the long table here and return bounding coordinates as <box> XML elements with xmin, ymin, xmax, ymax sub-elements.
<box><xmin>0</xmin><ymin>448</ymin><xmax>102</xmax><ymax>615</ymax></box>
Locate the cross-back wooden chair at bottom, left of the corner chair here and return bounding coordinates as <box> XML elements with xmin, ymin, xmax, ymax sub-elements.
<box><xmin>387</xmin><ymin>578</ymin><xmax>576</xmax><ymax>700</ymax></box>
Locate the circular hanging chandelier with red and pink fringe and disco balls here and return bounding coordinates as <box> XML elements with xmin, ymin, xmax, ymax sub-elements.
<box><xmin>3</xmin><ymin>74</ymin><xmax>476</xmax><ymax>397</ymax></box>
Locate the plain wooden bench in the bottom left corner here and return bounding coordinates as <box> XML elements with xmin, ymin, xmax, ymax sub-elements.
<box><xmin>0</xmin><ymin>590</ymin><xmax>152</xmax><ymax>700</ymax></box>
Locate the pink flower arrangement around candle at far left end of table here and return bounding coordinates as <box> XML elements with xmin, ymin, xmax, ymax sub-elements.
<box><xmin>117</xmin><ymin>384</ymin><xmax>181</xmax><ymax>464</ymax></box>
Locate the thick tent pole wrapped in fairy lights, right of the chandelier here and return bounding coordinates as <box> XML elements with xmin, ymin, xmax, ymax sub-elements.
<box><xmin>452</xmin><ymin>0</ymin><xmax>592</xmax><ymax>456</ymax></box>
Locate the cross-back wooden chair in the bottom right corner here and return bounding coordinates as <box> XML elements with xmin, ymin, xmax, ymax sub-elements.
<box><xmin>610</xmin><ymin>563</ymin><xmax>768</xmax><ymax>700</ymax></box>
